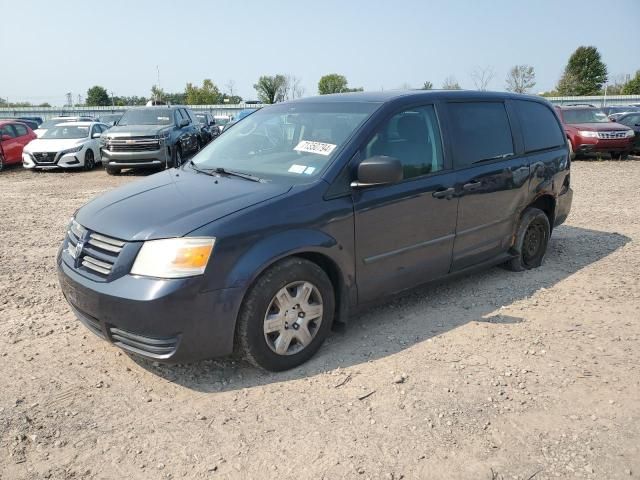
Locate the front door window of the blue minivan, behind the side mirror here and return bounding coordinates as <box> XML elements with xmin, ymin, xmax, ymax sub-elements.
<box><xmin>365</xmin><ymin>105</ymin><xmax>444</xmax><ymax>179</ymax></box>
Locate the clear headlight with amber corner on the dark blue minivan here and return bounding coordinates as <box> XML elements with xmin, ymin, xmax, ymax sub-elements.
<box><xmin>131</xmin><ymin>237</ymin><xmax>216</xmax><ymax>278</ymax></box>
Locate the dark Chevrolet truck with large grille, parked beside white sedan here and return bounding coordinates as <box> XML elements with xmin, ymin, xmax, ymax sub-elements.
<box><xmin>101</xmin><ymin>106</ymin><xmax>200</xmax><ymax>175</ymax></box>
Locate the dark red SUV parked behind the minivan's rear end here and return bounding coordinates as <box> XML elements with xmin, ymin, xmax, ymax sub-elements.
<box><xmin>556</xmin><ymin>105</ymin><xmax>634</xmax><ymax>159</ymax></box>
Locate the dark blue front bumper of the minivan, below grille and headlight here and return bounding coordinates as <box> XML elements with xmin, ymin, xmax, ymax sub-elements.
<box><xmin>57</xmin><ymin>254</ymin><xmax>244</xmax><ymax>363</ymax></box>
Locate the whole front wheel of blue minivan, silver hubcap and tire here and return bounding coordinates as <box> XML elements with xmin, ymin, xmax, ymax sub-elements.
<box><xmin>236</xmin><ymin>257</ymin><xmax>335</xmax><ymax>371</ymax></box>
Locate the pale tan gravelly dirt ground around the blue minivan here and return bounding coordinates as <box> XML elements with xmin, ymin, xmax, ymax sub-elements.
<box><xmin>0</xmin><ymin>159</ymin><xmax>640</xmax><ymax>480</ymax></box>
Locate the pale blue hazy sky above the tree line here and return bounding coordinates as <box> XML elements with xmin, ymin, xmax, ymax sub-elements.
<box><xmin>0</xmin><ymin>0</ymin><xmax>640</xmax><ymax>105</ymax></box>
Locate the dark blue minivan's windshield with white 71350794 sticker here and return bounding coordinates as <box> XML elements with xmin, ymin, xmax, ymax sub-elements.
<box><xmin>193</xmin><ymin>102</ymin><xmax>379</xmax><ymax>183</ymax></box>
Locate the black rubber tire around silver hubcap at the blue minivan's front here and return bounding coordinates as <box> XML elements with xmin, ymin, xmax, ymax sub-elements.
<box><xmin>236</xmin><ymin>257</ymin><xmax>335</xmax><ymax>372</ymax></box>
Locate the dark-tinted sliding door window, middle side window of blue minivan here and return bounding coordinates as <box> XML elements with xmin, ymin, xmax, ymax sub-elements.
<box><xmin>449</xmin><ymin>102</ymin><xmax>513</xmax><ymax>168</ymax></box>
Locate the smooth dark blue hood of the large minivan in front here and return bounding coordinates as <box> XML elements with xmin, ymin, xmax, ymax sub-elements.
<box><xmin>76</xmin><ymin>166</ymin><xmax>291</xmax><ymax>241</ymax></box>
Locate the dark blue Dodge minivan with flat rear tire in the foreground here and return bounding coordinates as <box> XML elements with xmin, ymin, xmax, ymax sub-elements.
<box><xmin>57</xmin><ymin>91</ymin><xmax>572</xmax><ymax>370</ymax></box>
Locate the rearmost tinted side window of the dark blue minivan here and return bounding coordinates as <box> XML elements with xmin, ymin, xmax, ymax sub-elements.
<box><xmin>514</xmin><ymin>100</ymin><xmax>564</xmax><ymax>153</ymax></box>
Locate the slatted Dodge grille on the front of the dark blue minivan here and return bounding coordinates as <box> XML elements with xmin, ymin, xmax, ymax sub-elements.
<box><xmin>67</xmin><ymin>221</ymin><xmax>126</xmax><ymax>278</ymax></box>
